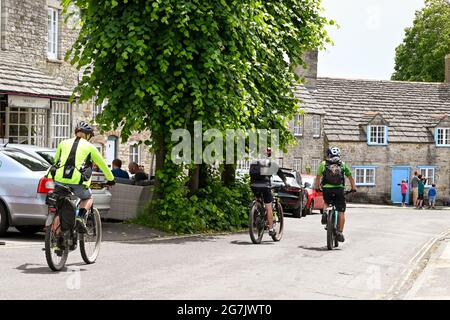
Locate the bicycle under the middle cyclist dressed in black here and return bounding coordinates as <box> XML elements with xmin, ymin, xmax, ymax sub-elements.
<box><xmin>249</xmin><ymin>186</ymin><xmax>283</xmax><ymax>244</ymax></box>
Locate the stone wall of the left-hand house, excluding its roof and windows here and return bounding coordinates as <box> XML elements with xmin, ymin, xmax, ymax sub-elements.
<box><xmin>0</xmin><ymin>0</ymin><xmax>152</xmax><ymax>173</ymax></box>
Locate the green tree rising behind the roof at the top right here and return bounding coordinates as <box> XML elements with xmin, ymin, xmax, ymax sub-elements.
<box><xmin>392</xmin><ymin>0</ymin><xmax>450</xmax><ymax>82</ymax></box>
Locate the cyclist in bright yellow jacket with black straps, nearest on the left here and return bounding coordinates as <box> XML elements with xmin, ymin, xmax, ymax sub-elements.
<box><xmin>49</xmin><ymin>121</ymin><xmax>115</xmax><ymax>233</ymax></box>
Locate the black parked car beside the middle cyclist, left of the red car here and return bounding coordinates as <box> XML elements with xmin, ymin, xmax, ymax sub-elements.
<box><xmin>272</xmin><ymin>168</ymin><xmax>308</xmax><ymax>218</ymax></box>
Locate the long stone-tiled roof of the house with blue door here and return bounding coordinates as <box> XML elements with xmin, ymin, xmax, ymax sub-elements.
<box><xmin>311</xmin><ymin>78</ymin><xmax>450</xmax><ymax>143</ymax></box>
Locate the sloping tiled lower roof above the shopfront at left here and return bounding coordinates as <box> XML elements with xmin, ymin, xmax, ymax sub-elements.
<box><xmin>0</xmin><ymin>50</ymin><xmax>72</xmax><ymax>98</ymax></box>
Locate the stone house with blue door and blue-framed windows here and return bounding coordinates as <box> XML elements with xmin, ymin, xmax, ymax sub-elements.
<box><xmin>285</xmin><ymin>55</ymin><xmax>450</xmax><ymax>203</ymax></box>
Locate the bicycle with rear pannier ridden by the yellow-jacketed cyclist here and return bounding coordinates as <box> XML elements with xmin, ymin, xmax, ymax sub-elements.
<box><xmin>45</xmin><ymin>184</ymin><xmax>102</xmax><ymax>271</ymax></box>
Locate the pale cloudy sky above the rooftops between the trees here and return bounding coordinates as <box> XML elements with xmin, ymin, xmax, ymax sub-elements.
<box><xmin>318</xmin><ymin>0</ymin><xmax>424</xmax><ymax>80</ymax></box>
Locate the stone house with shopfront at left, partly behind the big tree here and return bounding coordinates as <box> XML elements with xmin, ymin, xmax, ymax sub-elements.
<box><xmin>0</xmin><ymin>0</ymin><xmax>152</xmax><ymax>172</ymax></box>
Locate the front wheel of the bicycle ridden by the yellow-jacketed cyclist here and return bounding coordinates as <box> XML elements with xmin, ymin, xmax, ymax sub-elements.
<box><xmin>79</xmin><ymin>208</ymin><xmax>102</xmax><ymax>264</ymax></box>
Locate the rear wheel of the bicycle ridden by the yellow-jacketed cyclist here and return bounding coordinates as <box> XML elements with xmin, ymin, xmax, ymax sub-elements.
<box><xmin>45</xmin><ymin>218</ymin><xmax>69</xmax><ymax>271</ymax></box>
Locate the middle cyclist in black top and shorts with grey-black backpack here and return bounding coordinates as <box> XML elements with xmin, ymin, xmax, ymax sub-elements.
<box><xmin>250</xmin><ymin>148</ymin><xmax>287</xmax><ymax>236</ymax></box>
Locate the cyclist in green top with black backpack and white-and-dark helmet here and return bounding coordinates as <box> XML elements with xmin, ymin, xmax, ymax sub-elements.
<box><xmin>314</xmin><ymin>147</ymin><xmax>356</xmax><ymax>242</ymax></box>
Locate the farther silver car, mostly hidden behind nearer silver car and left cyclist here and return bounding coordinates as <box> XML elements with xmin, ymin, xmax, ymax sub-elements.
<box><xmin>7</xmin><ymin>144</ymin><xmax>112</xmax><ymax>215</ymax></box>
